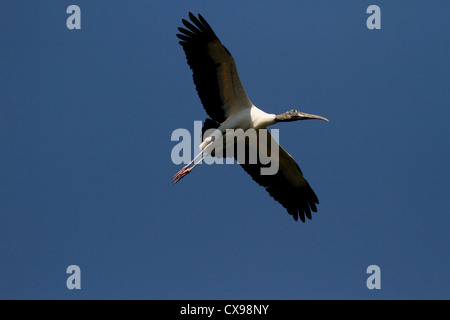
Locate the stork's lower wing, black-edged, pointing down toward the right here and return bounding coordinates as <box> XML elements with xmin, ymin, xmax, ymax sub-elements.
<box><xmin>234</xmin><ymin>129</ymin><xmax>319</xmax><ymax>222</ymax></box>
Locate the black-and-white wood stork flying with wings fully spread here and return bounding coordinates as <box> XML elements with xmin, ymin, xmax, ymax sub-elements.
<box><xmin>172</xmin><ymin>12</ymin><xmax>328</xmax><ymax>222</ymax></box>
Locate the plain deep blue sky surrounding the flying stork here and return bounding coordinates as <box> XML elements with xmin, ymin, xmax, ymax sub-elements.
<box><xmin>0</xmin><ymin>0</ymin><xmax>450</xmax><ymax>299</ymax></box>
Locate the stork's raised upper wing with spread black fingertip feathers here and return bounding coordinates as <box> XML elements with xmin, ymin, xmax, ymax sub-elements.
<box><xmin>177</xmin><ymin>13</ymin><xmax>252</xmax><ymax>123</ymax></box>
